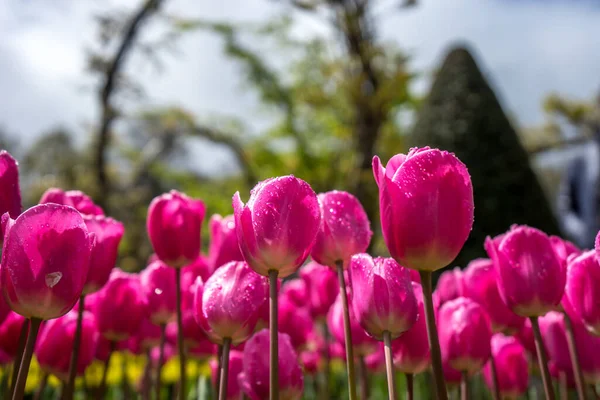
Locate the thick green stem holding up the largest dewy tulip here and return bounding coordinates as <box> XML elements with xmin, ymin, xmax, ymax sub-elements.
<box><xmin>419</xmin><ymin>271</ymin><xmax>448</xmax><ymax>400</ymax></box>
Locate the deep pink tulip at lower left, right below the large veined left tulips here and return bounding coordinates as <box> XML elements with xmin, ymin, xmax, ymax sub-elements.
<box><xmin>94</xmin><ymin>269</ymin><xmax>148</xmax><ymax>341</ymax></box>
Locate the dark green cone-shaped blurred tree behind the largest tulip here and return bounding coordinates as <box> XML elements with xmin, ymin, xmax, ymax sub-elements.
<box><xmin>411</xmin><ymin>47</ymin><xmax>558</xmax><ymax>266</ymax></box>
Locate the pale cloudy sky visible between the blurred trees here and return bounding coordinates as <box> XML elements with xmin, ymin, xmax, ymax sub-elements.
<box><xmin>0</xmin><ymin>0</ymin><xmax>600</xmax><ymax>171</ymax></box>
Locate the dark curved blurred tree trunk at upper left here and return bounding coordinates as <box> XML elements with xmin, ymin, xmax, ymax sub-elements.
<box><xmin>95</xmin><ymin>0</ymin><xmax>163</xmax><ymax>208</ymax></box>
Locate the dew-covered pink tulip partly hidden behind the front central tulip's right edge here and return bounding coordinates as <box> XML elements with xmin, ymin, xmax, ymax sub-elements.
<box><xmin>311</xmin><ymin>190</ymin><xmax>373</xmax><ymax>267</ymax></box>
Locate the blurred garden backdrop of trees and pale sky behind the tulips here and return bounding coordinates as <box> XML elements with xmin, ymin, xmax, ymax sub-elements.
<box><xmin>0</xmin><ymin>0</ymin><xmax>600</xmax><ymax>270</ymax></box>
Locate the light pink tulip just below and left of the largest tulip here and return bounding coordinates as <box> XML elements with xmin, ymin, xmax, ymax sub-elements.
<box><xmin>350</xmin><ymin>253</ymin><xmax>418</xmax><ymax>341</ymax></box>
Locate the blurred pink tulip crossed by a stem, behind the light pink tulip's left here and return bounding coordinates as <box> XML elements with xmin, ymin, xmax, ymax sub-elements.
<box><xmin>327</xmin><ymin>294</ymin><xmax>378</xmax><ymax>356</ymax></box>
